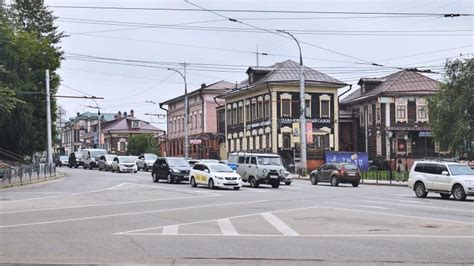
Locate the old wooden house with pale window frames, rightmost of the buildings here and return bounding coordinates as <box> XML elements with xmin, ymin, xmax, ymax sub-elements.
<box><xmin>340</xmin><ymin>70</ymin><xmax>443</xmax><ymax>166</ymax></box>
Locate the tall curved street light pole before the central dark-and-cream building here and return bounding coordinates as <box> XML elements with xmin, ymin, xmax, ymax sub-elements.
<box><xmin>277</xmin><ymin>30</ymin><xmax>307</xmax><ymax>176</ymax></box>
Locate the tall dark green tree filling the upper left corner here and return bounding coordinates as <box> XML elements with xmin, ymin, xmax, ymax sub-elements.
<box><xmin>0</xmin><ymin>0</ymin><xmax>64</xmax><ymax>154</ymax></box>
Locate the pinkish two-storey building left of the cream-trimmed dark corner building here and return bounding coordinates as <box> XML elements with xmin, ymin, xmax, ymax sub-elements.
<box><xmin>160</xmin><ymin>81</ymin><xmax>235</xmax><ymax>159</ymax></box>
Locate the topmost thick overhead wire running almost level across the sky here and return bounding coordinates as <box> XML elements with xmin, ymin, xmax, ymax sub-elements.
<box><xmin>49</xmin><ymin>5</ymin><xmax>474</xmax><ymax>18</ymax></box>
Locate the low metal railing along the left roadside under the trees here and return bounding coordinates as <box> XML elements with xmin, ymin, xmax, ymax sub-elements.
<box><xmin>0</xmin><ymin>163</ymin><xmax>56</xmax><ymax>185</ymax></box>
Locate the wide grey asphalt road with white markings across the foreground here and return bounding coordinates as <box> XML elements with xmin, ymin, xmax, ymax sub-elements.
<box><xmin>0</xmin><ymin>168</ymin><xmax>474</xmax><ymax>265</ymax></box>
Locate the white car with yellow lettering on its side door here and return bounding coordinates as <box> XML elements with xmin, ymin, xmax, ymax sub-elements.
<box><xmin>189</xmin><ymin>163</ymin><xmax>242</xmax><ymax>190</ymax></box>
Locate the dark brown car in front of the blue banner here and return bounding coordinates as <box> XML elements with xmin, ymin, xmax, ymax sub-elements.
<box><xmin>310</xmin><ymin>163</ymin><xmax>360</xmax><ymax>187</ymax></box>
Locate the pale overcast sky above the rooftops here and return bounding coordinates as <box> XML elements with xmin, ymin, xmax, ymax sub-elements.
<box><xmin>42</xmin><ymin>0</ymin><xmax>474</xmax><ymax>128</ymax></box>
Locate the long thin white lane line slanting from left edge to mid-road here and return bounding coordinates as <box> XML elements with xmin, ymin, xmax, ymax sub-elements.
<box><xmin>0</xmin><ymin>200</ymin><xmax>269</xmax><ymax>228</ymax></box>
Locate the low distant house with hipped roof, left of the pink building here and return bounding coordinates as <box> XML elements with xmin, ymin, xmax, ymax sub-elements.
<box><xmin>84</xmin><ymin>110</ymin><xmax>165</xmax><ymax>155</ymax></box>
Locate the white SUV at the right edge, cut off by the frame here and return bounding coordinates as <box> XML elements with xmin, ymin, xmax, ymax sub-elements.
<box><xmin>408</xmin><ymin>161</ymin><xmax>474</xmax><ymax>200</ymax></box>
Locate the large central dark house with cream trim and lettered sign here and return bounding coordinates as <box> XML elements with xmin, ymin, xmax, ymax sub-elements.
<box><xmin>217</xmin><ymin>60</ymin><xmax>346</xmax><ymax>169</ymax></box>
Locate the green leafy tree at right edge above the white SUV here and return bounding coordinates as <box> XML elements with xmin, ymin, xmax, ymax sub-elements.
<box><xmin>428</xmin><ymin>58</ymin><xmax>474</xmax><ymax>160</ymax></box>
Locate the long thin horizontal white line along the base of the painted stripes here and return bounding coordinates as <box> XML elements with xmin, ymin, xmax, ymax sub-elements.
<box><xmin>123</xmin><ymin>233</ymin><xmax>474</xmax><ymax>239</ymax></box>
